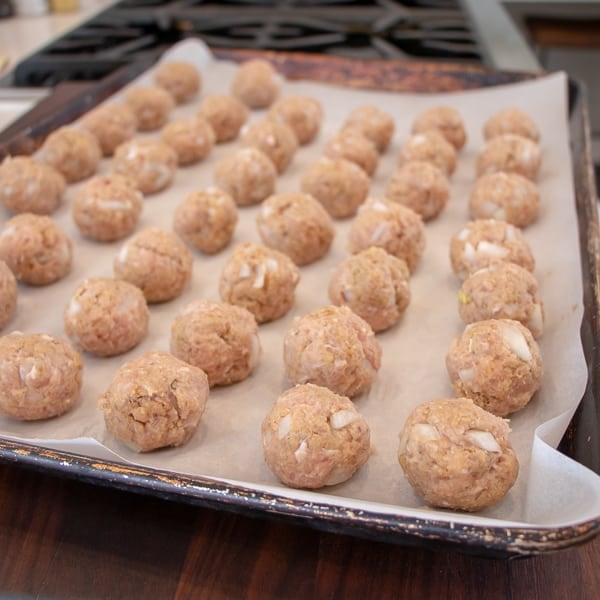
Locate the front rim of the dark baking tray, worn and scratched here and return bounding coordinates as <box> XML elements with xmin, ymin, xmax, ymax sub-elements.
<box><xmin>0</xmin><ymin>432</ymin><xmax>600</xmax><ymax>557</ymax></box>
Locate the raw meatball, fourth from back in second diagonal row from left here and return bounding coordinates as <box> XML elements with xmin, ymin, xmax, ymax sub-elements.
<box><xmin>112</xmin><ymin>139</ymin><xmax>177</xmax><ymax>194</ymax></box>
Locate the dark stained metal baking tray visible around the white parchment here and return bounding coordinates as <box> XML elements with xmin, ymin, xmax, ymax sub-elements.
<box><xmin>0</xmin><ymin>50</ymin><xmax>600</xmax><ymax>556</ymax></box>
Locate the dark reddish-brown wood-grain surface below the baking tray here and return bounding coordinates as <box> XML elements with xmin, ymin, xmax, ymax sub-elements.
<box><xmin>0</xmin><ymin>465</ymin><xmax>600</xmax><ymax>600</ymax></box>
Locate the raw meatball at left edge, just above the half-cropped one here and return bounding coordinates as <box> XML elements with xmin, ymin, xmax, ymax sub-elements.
<box><xmin>0</xmin><ymin>213</ymin><xmax>73</xmax><ymax>285</ymax></box>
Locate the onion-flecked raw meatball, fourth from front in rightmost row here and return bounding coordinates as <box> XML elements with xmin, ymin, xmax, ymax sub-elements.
<box><xmin>450</xmin><ymin>219</ymin><xmax>535</xmax><ymax>279</ymax></box>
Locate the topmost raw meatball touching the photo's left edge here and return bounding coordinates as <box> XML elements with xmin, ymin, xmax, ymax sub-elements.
<box><xmin>0</xmin><ymin>156</ymin><xmax>66</xmax><ymax>215</ymax></box>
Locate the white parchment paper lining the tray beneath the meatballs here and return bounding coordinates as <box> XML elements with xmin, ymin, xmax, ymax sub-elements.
<box><xmin>0</xmin><ymin>41</ymin><xmax>600</xmax><ymax>526</ymax></box>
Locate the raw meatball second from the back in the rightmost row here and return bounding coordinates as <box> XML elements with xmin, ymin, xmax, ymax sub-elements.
<box><xmin>477</xmin><ymin>133</ymin><xmax>542</xmax><ymax>180</ymax></box>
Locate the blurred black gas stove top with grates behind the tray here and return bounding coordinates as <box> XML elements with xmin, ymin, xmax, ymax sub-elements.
<box><xmin>12</xmin><ymin>0</ymin><xmax>483</xmax><ymax>87</ymax></box>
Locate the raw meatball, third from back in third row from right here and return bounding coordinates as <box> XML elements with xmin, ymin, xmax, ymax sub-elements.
<box><xmin>300</xmin><ymin>157</ymin><xmax>370</xmax><ymax>219</ymax></box>
